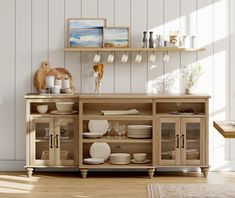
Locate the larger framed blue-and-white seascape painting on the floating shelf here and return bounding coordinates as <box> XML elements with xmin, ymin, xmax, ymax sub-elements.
<box><xmin>68</xmin><ymin>18</ymin><xmax>106</xmax><ymax>48</ymax></box>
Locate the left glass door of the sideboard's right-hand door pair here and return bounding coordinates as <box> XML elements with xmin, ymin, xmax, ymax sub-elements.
<box><xmin>158</xmin><ymin>118</ymin><xmax>180</xmax><ymax>165</ymax></box>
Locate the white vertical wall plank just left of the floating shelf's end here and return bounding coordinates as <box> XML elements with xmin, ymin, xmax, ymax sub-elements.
<box><xmin>48</xmin><ymin>0</ymin><xmax>64</xmax><ymax>67</ymax></box>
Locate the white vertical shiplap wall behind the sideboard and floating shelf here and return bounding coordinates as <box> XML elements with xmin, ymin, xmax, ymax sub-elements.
<box><xmin>0</xmin><ymin>0</ymin><xmax>235</xmax><ymax>170</ymax></box>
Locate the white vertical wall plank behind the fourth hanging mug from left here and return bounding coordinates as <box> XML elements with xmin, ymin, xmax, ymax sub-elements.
<box><xmin>131</xmin><ymin>0</ymin><xmax>148</xmax><ymax>93</ymax></box>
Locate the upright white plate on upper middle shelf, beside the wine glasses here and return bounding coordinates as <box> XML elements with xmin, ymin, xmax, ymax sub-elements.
<box><xmin>88</xmin><ymin>120</ymin><xmax>109</xmax><ymax>135</ymax></box>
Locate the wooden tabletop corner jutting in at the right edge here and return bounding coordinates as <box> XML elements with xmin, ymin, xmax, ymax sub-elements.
<box><xmin>213</xmin><ymin>121</ymin><xmax>235</xmax><ymax>138</ymax></box>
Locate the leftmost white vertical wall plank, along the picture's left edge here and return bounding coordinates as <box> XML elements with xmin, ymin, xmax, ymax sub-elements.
<box><xmin>0</xmin><ymin>0</ymin><xmax>15</xmax><ymax>160</ymax></box>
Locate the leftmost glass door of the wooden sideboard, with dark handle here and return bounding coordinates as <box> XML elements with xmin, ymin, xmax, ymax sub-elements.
<box><xmin>30</xmin><ymin>118</ymin><xmax>54</xmax><ymax>166</ymax></box>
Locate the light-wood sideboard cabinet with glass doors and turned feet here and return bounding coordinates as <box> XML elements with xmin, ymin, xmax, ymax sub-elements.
<box><xmin>25</xmin><ymin>94</ymin><xmax>210</xmax><ymax>178</ymax></box>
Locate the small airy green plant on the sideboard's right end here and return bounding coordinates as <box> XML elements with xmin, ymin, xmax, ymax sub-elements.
<box><xmin>183</xmin><ymin>64</ymin><xmax>202</xmax><ymax>94</ymax></box>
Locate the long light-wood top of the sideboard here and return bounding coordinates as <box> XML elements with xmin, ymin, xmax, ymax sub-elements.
<box><xmin>24</xmin><ymin>93</ymin><xmax>210</xmax><ymax>99</ymax></box>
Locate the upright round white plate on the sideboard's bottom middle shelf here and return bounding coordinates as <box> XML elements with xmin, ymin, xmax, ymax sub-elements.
<box><xmin>90</xmin><ymin>142</ymin><xmax>111</xmax><ymax>161</ymax></box>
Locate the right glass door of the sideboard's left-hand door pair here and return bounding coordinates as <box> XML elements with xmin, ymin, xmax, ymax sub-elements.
<box><xmin>55</xmin><ymin>118</ymin><xmax>76</xmax><ymax>166</ymax></box>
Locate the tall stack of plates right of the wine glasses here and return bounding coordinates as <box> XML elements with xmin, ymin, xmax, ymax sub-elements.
<box><xmin>127</xmin><ymin>125</ymin><xmax>152</xmax><ymax>138</ymax></box>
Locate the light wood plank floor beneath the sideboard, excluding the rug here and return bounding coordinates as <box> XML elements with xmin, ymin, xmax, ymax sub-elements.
<box><xmin>0</xmin><ymin>172</ymin><xmax>235</xmax><ymax>198</ymax></box>
